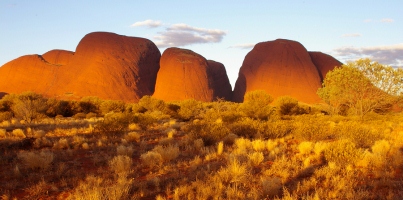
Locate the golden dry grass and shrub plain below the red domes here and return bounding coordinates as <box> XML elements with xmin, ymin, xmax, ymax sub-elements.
<box><xmin>0</xmin><ymin>93</ymin><xmax>403</xmax><ymax>200</ymax></box>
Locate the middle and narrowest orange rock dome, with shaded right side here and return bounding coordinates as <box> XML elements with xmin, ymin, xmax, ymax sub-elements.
<box><xmin>153</xmin><ymin>48</ymin><xmax>232</xmax><ymax>101</ymax></box>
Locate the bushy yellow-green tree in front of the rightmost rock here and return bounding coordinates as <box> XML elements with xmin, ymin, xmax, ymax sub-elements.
<box><xmin>318</xmin><ymin>60</ymin><xmax>393</xmax><ymax>117</ymax></box>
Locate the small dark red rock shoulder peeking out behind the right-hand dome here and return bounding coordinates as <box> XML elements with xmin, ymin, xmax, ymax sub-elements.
<box><xmin>309</xmin><ymin>52</ymin><xmax>343</xmax><ymax>81</ymax></box>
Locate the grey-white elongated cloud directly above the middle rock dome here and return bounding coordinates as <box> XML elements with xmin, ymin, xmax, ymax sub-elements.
<box><xmin>154</xmin><ymin>24</ymin><xmax>226</xmax><ymax>48</ymax></box>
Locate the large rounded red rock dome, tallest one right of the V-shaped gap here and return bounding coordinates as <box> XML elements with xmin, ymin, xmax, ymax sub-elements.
<box><xmin>233</xmin><ymin>39</ymin><xmax>340</xmax><ymax>103</ymax></box>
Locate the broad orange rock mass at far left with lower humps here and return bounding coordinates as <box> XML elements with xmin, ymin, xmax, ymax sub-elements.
<box><xmin>0</xmin><ymin>32</ymin><xmax>161</xmax><ymax>102</ymax></box>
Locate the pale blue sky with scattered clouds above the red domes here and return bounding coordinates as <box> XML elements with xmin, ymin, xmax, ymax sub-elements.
<box><xmin>0</xmin><ymin>0</ymin><xmax>403</xmax><ymax>87</ymax></box>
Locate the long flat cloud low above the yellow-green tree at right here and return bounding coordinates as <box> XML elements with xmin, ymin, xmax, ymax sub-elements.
<box><xmin>332</xmin><ymin>43</ymin><xmax>403</xmax><ymax>67</ymax></box>
